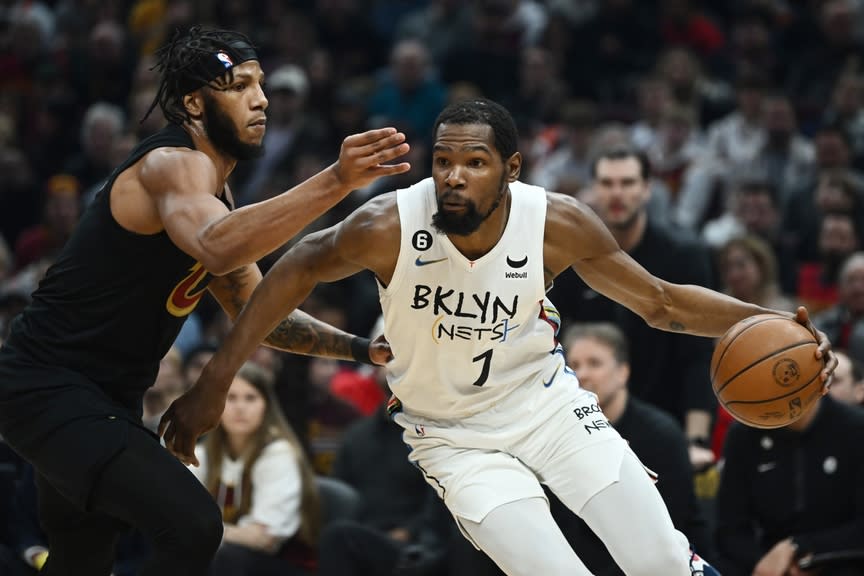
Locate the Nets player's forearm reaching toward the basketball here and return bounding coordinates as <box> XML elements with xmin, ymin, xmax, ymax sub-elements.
<box><xmin>647</xmin><ymin>283</ymin><xmax>787</xmax><ymax>338</ymax></box>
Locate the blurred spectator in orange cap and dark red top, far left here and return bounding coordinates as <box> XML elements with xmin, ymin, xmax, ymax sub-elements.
<box><xmin>15</xmin><ymin>174</ymin><xmax>81</xmax><ymax>270</ymax></box>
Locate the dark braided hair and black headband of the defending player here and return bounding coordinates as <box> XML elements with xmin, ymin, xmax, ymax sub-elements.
<box><xmin>141</xmin><ymin>26</ymin><xmax>258</xmax><ymax>124</ymax></box>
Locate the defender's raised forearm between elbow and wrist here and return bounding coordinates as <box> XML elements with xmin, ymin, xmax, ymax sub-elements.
<box><xmin>199</xmin><ymin>166</ymin><xmax>351</xmax><ymax>275</ymax></box>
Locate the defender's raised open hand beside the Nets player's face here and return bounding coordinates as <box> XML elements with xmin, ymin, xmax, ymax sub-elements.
<box><xmin>333</xmin><ymin>128</ymin><xmax>411</xmax><ymax>190</ymax></box>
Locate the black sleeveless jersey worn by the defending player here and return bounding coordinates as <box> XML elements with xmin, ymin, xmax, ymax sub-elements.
<box><xmin>8</xmin><ymin>125</ymin><xmax>227</xmax><ymax>410</ymax></box>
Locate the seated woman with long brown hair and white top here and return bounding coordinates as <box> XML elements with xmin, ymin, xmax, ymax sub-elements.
<box><xmin>190</xmin><ymin>363</ymin><xmax>320</xmax><ymax>576</ymax></box>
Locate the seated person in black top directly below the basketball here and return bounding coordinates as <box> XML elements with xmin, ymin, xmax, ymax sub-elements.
<box><xmin>716</xmin><ymin>395</ymin><xmax>864</xmax><ymax>576</ymax></box>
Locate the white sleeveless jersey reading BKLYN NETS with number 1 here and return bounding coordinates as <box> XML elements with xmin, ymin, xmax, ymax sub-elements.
<box><xmin>379</xmin><ymin>178</ymin><xmax>564</xmax><ymax>419</ymax></box>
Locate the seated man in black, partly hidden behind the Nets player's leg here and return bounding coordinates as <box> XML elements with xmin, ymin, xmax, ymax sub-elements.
<box><xmin>553</xmin><ymin>323</ymin><xmax>712</xmax><ymax>576</ymax></box>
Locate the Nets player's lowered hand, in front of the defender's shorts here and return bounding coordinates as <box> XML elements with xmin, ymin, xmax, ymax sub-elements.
<box><xmin>159</xmin><ymin>372</ymin><xmax>228</xmax><ymax>466</ymax></box>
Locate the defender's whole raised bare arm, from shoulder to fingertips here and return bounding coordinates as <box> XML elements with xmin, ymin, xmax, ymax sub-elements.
<box><xmin>141</xmin><ymin>128</ymin><xmax>410</xmax><ymax>276</ymax></box>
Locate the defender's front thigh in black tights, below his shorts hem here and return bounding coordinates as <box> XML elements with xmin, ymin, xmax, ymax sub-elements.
<box><xmin>90</xmin><ymin>426</ymin><xmax>221</xmax><ymax>538</ymax></box>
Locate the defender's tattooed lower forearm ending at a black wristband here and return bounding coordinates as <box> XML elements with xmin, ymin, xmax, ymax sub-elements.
<box><xmin>266</xmin><ymin>310</ymin><xmax>353</xmax><ymax>360</ymax></box>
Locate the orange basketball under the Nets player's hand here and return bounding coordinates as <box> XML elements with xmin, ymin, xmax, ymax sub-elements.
<box><xmin>711</xmin><ymin>314</ymin><xmax>824</xmax><ymax>428</ymax></box>
